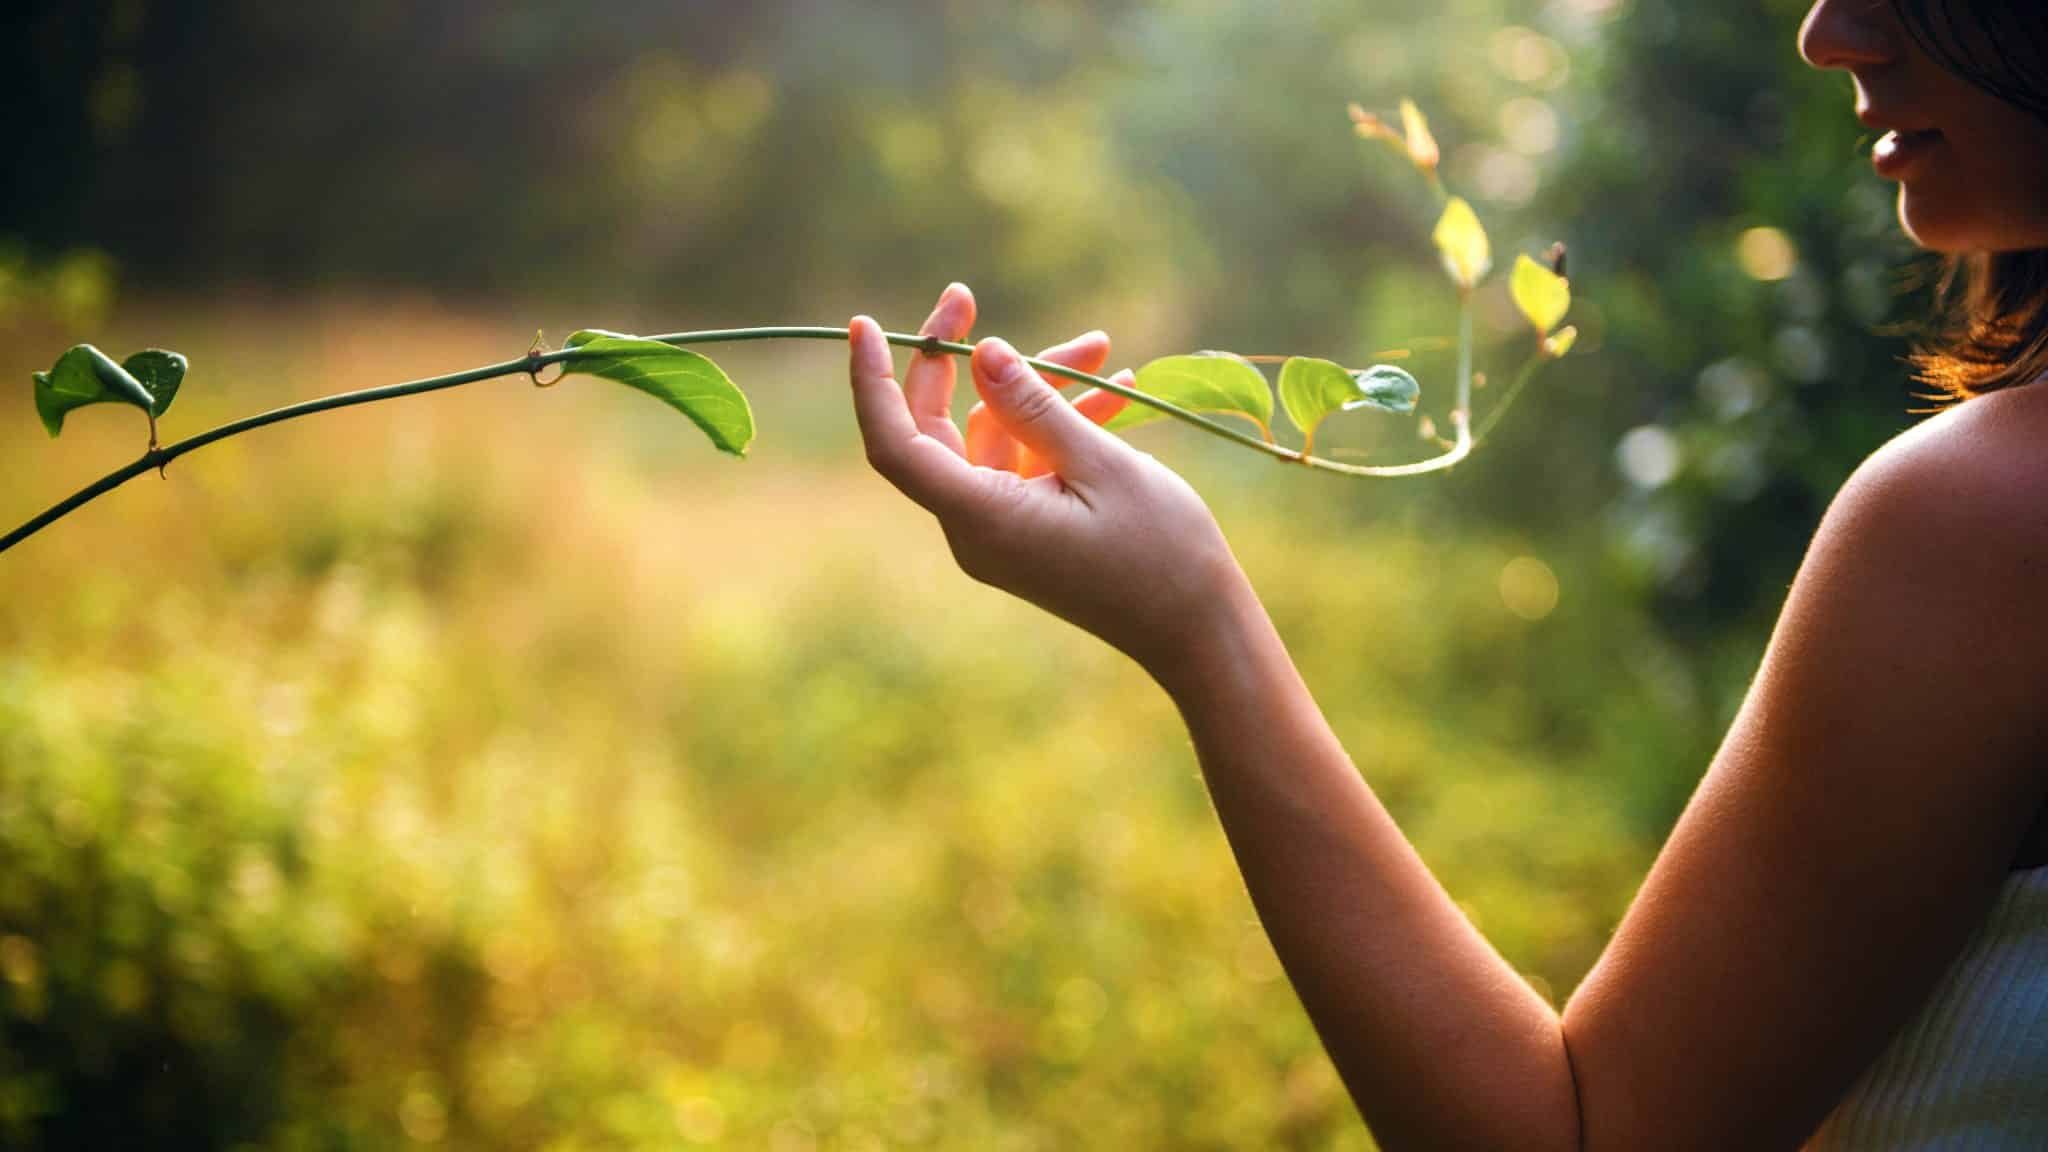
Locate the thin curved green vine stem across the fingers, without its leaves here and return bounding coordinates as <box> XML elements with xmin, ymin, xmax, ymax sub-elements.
<box><xmin>0</xmin><ymin>315</ymin><xmax>1473</xmax><ymax>551</ymax></box>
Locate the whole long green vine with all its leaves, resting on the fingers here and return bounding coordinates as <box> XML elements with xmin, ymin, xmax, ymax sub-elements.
<box><xmin>0</xmin><ymin>100</ymin><xmax>1577</xmax><ymax>551</ymax></box>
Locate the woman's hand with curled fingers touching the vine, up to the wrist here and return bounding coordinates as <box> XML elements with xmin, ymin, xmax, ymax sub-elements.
<box><xmin>850</xmin><ymin>285</ymin><xmax>1243</xmax><ymax>678</ymax></box>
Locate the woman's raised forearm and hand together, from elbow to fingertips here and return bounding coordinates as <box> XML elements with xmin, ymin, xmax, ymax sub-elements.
<box><xmin>848</xmin><ymin>301</ymin><xmax>1579</xmax><ymax>1150</ymax></box>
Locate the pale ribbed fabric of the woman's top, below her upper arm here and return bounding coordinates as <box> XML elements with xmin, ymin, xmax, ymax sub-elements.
<box><xmin>1806</xmin><ymin>867</ymin><xmax>2048</xmax><ymax>1152</ymax></box>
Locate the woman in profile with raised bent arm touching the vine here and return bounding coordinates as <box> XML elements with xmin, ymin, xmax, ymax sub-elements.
<box><xmin>852</xmin><ymin>0</ymin><xmax>2048</xmax><ymax>1150</ymax></box>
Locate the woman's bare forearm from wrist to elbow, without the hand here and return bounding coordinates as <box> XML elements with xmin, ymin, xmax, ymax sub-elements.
<box><xmin>1155</xmin><ymin>584</ymin><xmax>1579</xmax><ymax>1150</ymax></box>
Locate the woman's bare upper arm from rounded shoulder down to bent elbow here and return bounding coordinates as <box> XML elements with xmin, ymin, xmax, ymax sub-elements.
<box><xmin>1565</xmin><ymin>398</ymin><xmax>2048</xmax><ymax>1148</ymax></box>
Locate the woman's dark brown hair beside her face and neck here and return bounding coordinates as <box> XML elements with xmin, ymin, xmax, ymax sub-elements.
<box><xmin>1892</xmin><ymin>0</ymin><xmax>2048</xmax><ymax>400</ymax></box>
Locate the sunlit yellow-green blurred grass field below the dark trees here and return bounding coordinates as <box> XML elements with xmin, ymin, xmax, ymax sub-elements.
<box><xmin>0</xmin><ymin>301</ymin><xmax>1667</xmax><ymax>1152</ymax></box>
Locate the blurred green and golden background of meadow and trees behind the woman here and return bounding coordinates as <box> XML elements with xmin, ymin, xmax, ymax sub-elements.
<box><xmin>0</xmin><ymin>0</ymin><xmax>1925</xmax><ymax>1152</ymax></box>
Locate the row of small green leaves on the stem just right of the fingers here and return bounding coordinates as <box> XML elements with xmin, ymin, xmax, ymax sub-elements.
<box><xmin>1104</xmin><ymin>353</ymin><xmax>1421</xmax><ymax>445</ymax></box>
